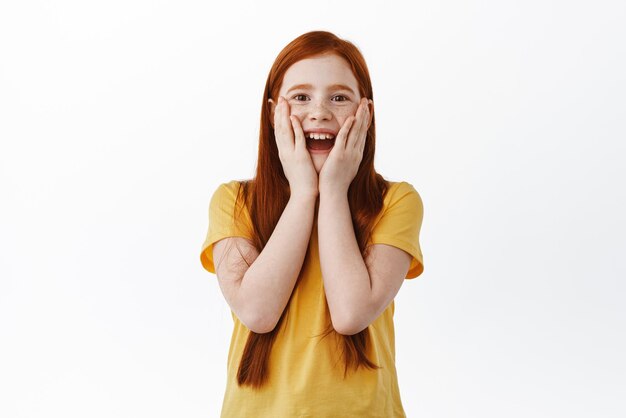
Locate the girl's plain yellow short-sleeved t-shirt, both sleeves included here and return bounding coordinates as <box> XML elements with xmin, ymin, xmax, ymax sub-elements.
<box><xmin>200</xmin><ymin>180</ymin><xmax>424</xmax><ymax>418</ymax></box>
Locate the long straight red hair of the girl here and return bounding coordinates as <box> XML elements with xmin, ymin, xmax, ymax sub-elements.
<box><xmin>229</xmin><ymin>31</ymin><xmax>388</xmax><ymax>388</ymax></box>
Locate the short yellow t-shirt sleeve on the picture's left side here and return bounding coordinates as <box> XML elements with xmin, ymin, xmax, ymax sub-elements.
<box><xmin>200</xmin><ymin>180</ymin><xmax>252</xmax><ymax>273</ymax></box>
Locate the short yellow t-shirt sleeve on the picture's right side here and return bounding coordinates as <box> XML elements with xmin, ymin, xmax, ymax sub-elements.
<box><xmin>370</xmin><ymin>181</ymin><xmax>424</xmax><ymax>279</ymax></box>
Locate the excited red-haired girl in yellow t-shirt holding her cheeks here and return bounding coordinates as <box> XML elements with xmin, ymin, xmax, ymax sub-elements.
<box><xmin>200</xmin><ymin>31</ymin><xmax>424</xmax><ymax>418</ymax></box>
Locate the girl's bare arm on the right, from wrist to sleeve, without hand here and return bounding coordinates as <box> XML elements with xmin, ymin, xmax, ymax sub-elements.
<box><xmin>318</xmin><ymin>192</ymin><xmax>411</xmax><ymax>335</ymax></box>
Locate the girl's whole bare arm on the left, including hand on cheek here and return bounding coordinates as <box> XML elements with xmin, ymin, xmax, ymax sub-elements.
<box><xmin>214</xmin><ymin>97</ymin><xmax>319</xmax><ymax>334</ymax></box>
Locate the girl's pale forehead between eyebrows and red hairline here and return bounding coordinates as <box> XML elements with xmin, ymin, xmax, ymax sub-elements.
<box><xmin>280</xmin><ymin>54</ymin><xmax>359</xmax><ymax>92</ymax></box>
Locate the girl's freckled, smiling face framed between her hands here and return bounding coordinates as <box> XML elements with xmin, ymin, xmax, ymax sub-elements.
<box><xmin>271</xmin><ymin>54</ymin><xmax>371</xmax><ymax>173</ymax></box>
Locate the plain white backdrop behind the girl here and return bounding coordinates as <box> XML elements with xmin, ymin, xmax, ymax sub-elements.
<box><xmin>0</xmin><ymin>0</ymin><xmax>626</xmax><ymax>418</ymax></box>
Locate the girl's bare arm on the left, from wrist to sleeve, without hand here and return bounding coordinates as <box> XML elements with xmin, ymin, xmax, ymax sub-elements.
<box><xmin>213</xmin><ymin>194</ymin><xmax>316</xmax><ymax>334</ymax></box>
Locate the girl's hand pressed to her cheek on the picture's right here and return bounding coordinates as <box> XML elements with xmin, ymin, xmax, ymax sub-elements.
<box><xmin>318</xmin><ymin>97</ymin><xmax>370</xmax><ymax>194</ymax></box>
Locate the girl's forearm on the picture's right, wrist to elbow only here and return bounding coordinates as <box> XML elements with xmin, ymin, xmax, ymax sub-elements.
<box><xmin>317</xmin><ymin>193</ymin><xmax>372</xmax><ymax>334</ymax></box>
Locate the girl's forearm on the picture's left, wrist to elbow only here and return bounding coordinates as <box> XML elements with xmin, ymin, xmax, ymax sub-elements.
<box><xmin>239</xmin><ymin>196</ymin><xmax>316</xmax><ymax>332</ymax></box>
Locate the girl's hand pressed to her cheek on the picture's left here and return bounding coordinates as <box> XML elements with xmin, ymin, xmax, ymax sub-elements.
<box><xmin>274</xmin><ymin>96</ymin><xmax>319</xmax><ymax>196</ymax></box>
